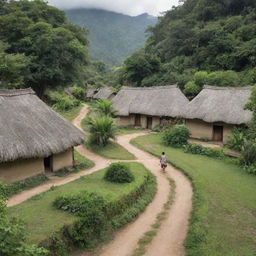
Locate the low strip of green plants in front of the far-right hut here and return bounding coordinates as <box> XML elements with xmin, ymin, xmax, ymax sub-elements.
<box><xmin>184</xmin><ymin>143</ymin><xmax>225</xmax><ymax>158</ymax></box>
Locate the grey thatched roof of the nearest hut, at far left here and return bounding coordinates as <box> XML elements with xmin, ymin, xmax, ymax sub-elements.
<box><xmin>0</xmin><ymin>89</ymin><xmax>84</xmax><ymax>162</ymax></box>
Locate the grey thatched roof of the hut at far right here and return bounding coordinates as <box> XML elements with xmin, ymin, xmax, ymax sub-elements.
<box><xmin>185</xmin><ymin>85</ymin><xmax>252</xmax><ymax>124</ymax></box>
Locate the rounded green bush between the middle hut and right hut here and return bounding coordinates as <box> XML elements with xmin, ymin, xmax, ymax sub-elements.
<box><xmin>162</xmin><ymin>125</ymin><xmax>190</xmax><ymax>147</ymax></box>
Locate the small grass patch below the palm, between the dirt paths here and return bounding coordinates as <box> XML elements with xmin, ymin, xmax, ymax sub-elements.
<box><xmin>86</xmin><ymin>142</ymin><xmax>136</xmax><ymax>160</ymax></box>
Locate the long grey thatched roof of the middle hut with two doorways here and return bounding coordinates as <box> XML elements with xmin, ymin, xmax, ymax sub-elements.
<box><xmin>112</xmin><ymin>85</ymin><xmax>189</xmax><ymax>117</ymax></box>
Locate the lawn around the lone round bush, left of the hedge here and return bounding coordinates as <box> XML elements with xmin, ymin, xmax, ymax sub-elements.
<box><xmin>9</xmin><ymin>163</ymin><xmax>148</xmax><ymax>243</ymax></box>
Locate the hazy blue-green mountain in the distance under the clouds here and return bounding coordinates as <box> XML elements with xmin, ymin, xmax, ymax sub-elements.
<box><xmin>66</xmin><ymin>9</ymin><xmax>157</xmax><ymax>65</ymax></box>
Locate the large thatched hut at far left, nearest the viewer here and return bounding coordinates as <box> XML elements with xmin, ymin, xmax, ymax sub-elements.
<box><xmin>0</xmin><ymin>89</ymin><xmax>84</xmax><ymax>183</ymax></box>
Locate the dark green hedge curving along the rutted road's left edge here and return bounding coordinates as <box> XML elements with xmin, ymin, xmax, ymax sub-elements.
<box><xmin>40</xmin><ymin>170</ymin><xmax>156</xmax><ymax>256</ymax></box>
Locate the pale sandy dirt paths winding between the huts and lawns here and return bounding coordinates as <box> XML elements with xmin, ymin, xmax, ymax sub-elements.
<box><xmin>8</xmin><ymin>105</ymin><xmax>192</xmax><ymax>256</ymax></box>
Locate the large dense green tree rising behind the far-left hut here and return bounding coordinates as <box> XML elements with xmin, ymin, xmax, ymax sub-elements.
<box><xmin>0</xmin><ymin>0</ymin><xmax>88</xmax><ymax>96</ymax></box>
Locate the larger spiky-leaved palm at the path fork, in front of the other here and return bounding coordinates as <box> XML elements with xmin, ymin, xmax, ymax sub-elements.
<box><xmin>86</xmin><ymin>116</ymin><xmax>116</xmax><ymax>146</ymax></box>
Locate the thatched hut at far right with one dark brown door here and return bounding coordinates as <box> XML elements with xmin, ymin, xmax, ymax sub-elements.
<box><xmin>184</xmin><ymin>85</ymin><xmax>252</xmax><ymax>143</ymax></box>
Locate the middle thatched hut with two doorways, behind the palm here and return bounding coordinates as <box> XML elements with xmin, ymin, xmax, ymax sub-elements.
<box><xmin>112</xmin><ymin>85</ymin><xmax>189</xmax><ymax>128</ymax></box>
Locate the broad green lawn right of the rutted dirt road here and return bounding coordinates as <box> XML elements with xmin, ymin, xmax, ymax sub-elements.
<box><xmin>133</xmin><ymin>135</ymin><xmax>256</xmax><ymax>256</ymax></box>
